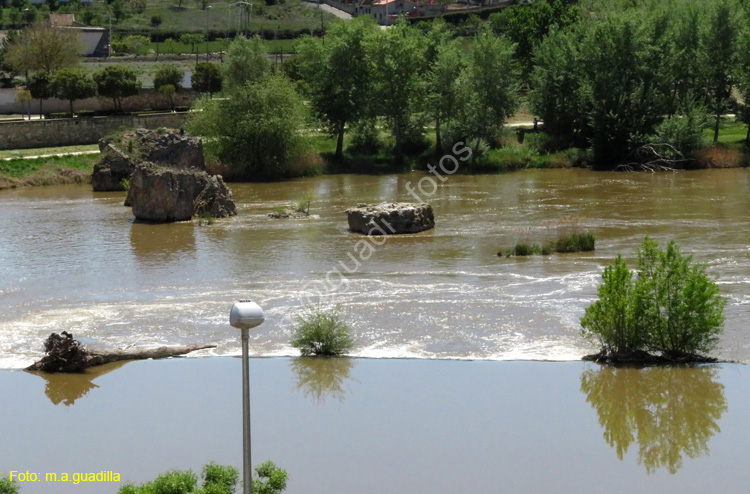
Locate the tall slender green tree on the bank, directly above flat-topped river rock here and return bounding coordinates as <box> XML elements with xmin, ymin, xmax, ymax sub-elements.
<box><xmin>370</xmin><ymin>21</ymin><xmax>427</xmax><ymax>161</ymax></box>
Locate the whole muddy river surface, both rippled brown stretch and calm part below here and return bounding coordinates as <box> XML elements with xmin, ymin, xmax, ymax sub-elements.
<box><xmin>0</xmin><ymin>170</ymin><xmax>750</xmax><ymax>494</ymax></box>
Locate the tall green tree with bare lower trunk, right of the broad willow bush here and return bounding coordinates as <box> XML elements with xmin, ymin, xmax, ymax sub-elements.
<box><xmin>296</xmin><ymin>17</ymin><xmax>377</xmax><ymax>160</ymax></box>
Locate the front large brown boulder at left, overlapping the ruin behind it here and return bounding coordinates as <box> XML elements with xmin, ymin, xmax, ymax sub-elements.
<box><xmin>126</xmin><ymin>163</ymin><xmax>237</xmax><ymax>222</ymax></box>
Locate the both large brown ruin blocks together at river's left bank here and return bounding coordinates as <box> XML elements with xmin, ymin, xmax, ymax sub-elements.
<box><xmin>91</xmin><ymin>129</ymin><xmax>237</xmax><ymax>222</ymax></box>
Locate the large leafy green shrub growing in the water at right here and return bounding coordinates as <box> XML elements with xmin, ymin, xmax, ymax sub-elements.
<box><xmin>581</xmin><ymin>237</ymin><xmax>726</xmax><ymax>361</ymax></box>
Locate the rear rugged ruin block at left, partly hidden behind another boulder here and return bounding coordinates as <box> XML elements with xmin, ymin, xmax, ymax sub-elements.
<box><xmin>91</xmin><ymin>129</ymin><xmax>206</xmax><ymax>192</ymax></box>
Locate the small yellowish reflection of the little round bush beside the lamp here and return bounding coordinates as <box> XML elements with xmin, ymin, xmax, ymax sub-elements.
<box><xmin>291</xmin><ymin>357</ymin><xmax>354</xmax><ymax>403</ymax></box>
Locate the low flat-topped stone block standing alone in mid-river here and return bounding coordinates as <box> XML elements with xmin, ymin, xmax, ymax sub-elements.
<box><xmin>346</xmin><ymin>202</ymin><xmax>435</xmax><ymax>235</ymax></box>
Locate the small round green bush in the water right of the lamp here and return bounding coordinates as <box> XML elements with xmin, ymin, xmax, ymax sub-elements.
<box><xmin>291</xmin><ymin>309</ymin><xmax>354</xmax><ymax>357</ymax></box>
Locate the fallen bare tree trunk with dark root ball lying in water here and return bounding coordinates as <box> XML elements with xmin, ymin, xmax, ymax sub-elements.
<box><xmin>26</xmin><ymin>331</ymin><xmax>216</xmax><ymax>373</ymax></box>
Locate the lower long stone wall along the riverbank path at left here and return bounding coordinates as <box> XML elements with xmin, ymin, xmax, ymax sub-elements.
<box><xmin>0</xmin><ymin>112</ymin><xmax>188</xmax><ymax>149</ymax></box>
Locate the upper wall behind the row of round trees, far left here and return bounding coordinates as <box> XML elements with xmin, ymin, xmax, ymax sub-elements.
<box><xmin>0</xmin><ymin>88</ymin><xmax>196</xmax><ymax>116</ymax></box>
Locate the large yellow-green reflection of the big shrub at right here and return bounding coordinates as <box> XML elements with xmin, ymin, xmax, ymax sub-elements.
<box><xmin>581</xmin><ymin>366</ymin><xmax>727</xmax><ymax>474</ymax></box>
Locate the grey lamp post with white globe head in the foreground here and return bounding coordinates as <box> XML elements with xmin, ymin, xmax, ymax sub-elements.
<box><xmin>229</xmin><ymin>300</ymin><xmax>265</xmax><ymax>494</ymax></box>
